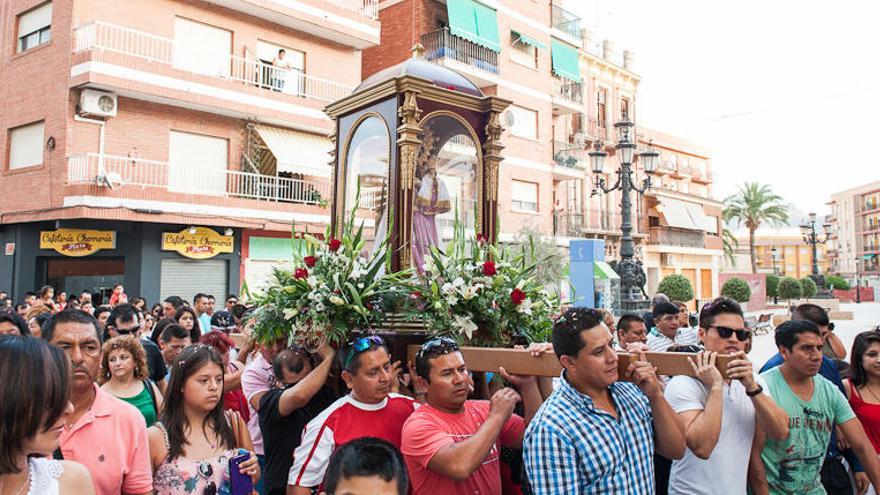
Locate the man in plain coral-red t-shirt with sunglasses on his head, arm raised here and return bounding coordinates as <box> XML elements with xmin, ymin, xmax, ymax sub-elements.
<box><xmin>401</xmin><ymin>338</ymin><xmax>541</xmax><ymax>495</ymax></box>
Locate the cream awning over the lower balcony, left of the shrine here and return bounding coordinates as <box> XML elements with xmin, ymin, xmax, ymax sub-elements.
<box><xmin>256</xmin><ymin>125</ymin><xmax>333</xmax><ymax>178</ymax></box>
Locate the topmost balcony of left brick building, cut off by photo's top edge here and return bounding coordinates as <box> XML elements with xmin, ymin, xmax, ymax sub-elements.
<box><xmin>198</xmin><ymin>0</ymin><xmax>379</xmax><ymax>50</ymax></box>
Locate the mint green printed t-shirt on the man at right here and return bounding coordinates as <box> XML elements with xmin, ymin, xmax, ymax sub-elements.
<box><xmin>761</xmin><ymin>367</ymin><xmax>856</xmax><ymax>495</ymax></box>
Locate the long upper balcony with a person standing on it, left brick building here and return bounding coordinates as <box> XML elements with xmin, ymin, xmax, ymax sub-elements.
<box><xmin>71</xmin><ymin>21</ymin><xmax>352</xmax><ymax>127</ymax></box>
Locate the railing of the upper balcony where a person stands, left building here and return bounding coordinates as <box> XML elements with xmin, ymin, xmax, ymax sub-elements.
<box><xmin>73</xmin><ymin>21</ymin><xmax>352</xmax><ymax>102</ymax></box>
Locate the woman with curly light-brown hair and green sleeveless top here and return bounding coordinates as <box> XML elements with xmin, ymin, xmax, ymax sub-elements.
<box><xmin>98</xmin><ymin>335</ymin><xmax>163</xmax><ymax>426</ymax></box>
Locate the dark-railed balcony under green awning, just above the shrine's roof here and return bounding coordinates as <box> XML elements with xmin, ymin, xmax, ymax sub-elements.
<box><xmin>421</xmin><ymin>28</ymin><xmax>500</xmax><ymax>88</ymax></box>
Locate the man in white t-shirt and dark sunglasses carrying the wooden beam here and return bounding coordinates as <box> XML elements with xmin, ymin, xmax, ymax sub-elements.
<box><xmin>665</xmin><ymin>298</ymin><xmax>788</xmax><ymax>495</ymax></box>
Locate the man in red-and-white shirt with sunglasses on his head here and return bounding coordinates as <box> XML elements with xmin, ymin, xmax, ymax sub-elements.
<box><xmin>287</xmin><ymin>335</ymin><xmax>417</xmax><ymax>495</ymax></box>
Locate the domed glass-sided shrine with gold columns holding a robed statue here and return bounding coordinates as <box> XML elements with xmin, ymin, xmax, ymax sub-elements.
<box><xmin>325</xmin><ymin>45</ymin><xmax>510</xmax><ymax>270</ymax></box>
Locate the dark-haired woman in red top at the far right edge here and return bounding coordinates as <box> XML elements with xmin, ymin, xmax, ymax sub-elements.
<box><xmin>844</xmin><ymin>331</ymin><xmax>880</xmax><ymax>460</ymax></box>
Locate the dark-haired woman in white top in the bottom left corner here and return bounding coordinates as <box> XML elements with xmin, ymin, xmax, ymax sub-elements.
<box><xmin>0</xmin><ymin>336</ymin><xmax>95</xmax><ymax>495</ymax></box>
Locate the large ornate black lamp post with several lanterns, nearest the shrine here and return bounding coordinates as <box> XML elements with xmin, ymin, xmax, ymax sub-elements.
<box><xmin>589</xmin><ymin>115</ymin><xmax>660</xmax><ymax>314</ymax></box>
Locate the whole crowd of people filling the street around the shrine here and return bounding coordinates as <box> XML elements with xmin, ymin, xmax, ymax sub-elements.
<box><xmin>0</xmin><ymin>286</ymin><xmax>880</xmax><ymax>495</ymax></box>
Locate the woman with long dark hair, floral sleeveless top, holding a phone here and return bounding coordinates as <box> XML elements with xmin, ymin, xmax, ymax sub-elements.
<box><xmin>147</xmin><ymin>344</ymin><xmax>260</xmax><ymax>495</ymax></box>
